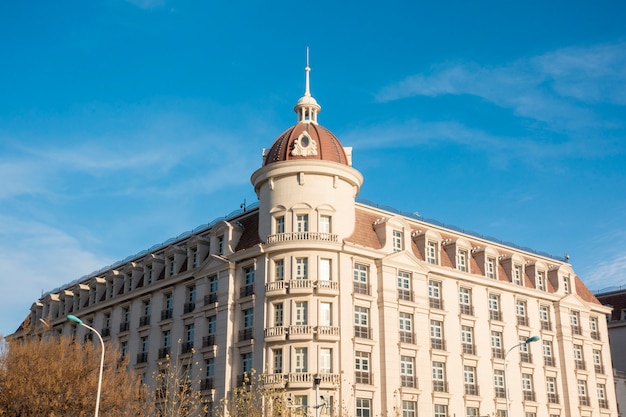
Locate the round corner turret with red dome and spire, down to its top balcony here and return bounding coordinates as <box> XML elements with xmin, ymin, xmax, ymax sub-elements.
<box><xmin>251</xmin><ymin>60</ymin><xmax>363</xmax><ymax>243</ymax></box>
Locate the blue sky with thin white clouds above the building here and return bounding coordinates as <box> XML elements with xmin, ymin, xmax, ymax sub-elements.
<box><xmin>0</xmin><ymin>0</ymin><xmax>626</xmax><ymax>334</ymax></box>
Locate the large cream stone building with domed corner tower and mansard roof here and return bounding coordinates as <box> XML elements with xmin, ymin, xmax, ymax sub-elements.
<box><xmin>14</xmin><ymin>62</ymin><xmax>617</xmax><ymax>417</ymax></box>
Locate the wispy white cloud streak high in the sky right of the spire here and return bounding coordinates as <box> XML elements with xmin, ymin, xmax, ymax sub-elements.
<box><xmin>376</xmin><ymin>43</ymin><xmax>626</xmax><ymax>131</ymax></box>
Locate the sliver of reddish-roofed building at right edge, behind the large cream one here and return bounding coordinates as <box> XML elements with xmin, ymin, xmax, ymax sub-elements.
<box><xmin>596</xmin><ymin>287</ymin><xmax>626</xmax><ymax>416</ymax></box>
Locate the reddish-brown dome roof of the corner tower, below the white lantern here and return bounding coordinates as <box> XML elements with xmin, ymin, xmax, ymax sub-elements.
<box><xmin>264</xmin><ymin>122</ymin><xmax>349</xmax><ymax>165</ymax></box>
